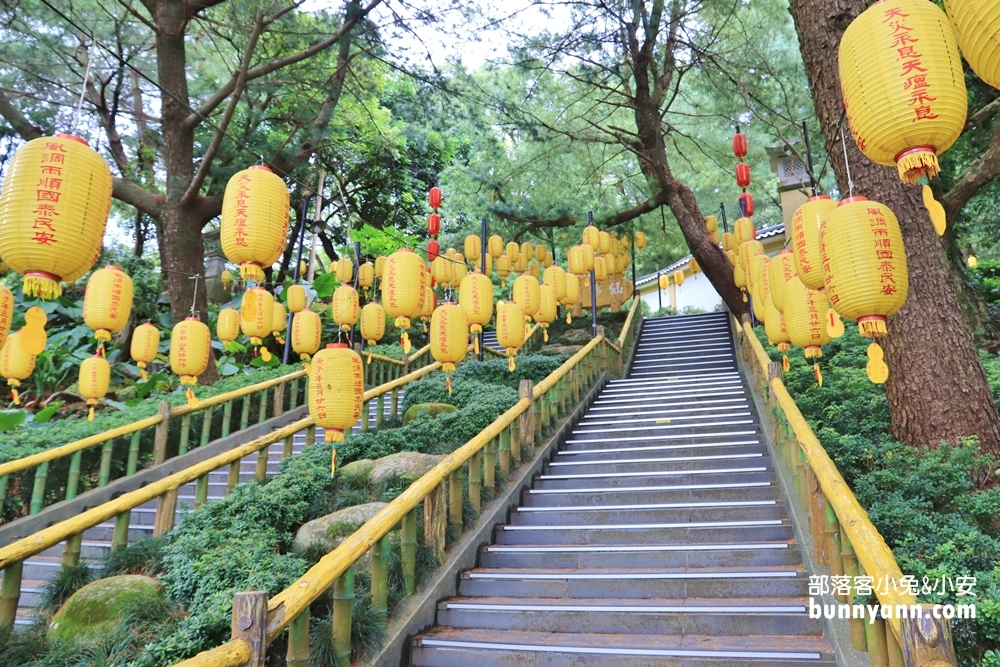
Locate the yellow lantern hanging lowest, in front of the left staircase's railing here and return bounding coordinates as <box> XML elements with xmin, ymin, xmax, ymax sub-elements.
<box><xmin>308</xmin><ymin>343</ymin><xmax>365</xmax><ymax>477</ymax></box>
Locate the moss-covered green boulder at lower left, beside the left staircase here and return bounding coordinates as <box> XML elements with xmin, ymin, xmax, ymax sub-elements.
<box><xmin>49</xmin><ymin>574</ymin><xmax>163</xmax><ymax>642</ymax></box>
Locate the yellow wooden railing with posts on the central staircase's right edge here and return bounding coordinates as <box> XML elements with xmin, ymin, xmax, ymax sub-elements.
<box><xmin>733</xmin><ymin>319</ymin><xmax>958</xmax><ymax>667</ymax></box>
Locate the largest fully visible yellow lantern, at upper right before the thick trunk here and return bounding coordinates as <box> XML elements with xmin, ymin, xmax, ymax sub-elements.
<box><xmin>840</xmin><ymin>0</ymin><xmax>964</xmax><ymax>234</ymax></box>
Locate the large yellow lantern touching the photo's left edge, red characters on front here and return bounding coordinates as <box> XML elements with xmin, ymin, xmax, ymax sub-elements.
<box><xmin>0</xmin><ymin>134</ymin><xmax>112</xmax><ymax>299</ymax></box>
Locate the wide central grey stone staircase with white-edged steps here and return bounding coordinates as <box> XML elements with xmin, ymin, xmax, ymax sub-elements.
<box><xmin>410</xmin><ymin>313</ymin><xmax>836</xmax><ymax>667</ymax></box>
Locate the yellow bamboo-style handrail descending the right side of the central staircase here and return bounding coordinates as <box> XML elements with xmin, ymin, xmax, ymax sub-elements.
<box><xmin>733</xmin><ymin>318</ymin><xmax>957</xmax><ymax>667</ymax></box>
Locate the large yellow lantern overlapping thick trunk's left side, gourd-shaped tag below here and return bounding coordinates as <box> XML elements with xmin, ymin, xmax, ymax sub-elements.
<box><xmin>820</xmin><ymin>197</ymin><xmax>909</xmax><ymax>381</ymax></box>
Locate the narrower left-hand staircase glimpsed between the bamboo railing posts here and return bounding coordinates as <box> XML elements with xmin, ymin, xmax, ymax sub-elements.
<box><xmin>15</xmin><ymin>390</ymin><xmax>404</xmax><ymax>625</ymax></box>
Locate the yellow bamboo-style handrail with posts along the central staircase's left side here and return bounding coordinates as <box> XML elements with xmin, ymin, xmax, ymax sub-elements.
<box><xmin>168</xmin><ymin>336</ymin><xmax>610</xmax><ymax>667</ymax></box>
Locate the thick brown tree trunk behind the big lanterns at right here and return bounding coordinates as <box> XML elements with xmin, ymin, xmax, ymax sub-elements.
<box><xmin>791</xmin><ymin>0</ymin><xmax>1000</xmax><ymax>453</ymax></box>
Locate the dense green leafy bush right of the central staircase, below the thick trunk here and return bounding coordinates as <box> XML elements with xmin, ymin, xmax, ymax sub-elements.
<box><xmin>757</xmin><ymin>326</ymin><xmax>1000</xmax><ymax>666</ymax></box>
